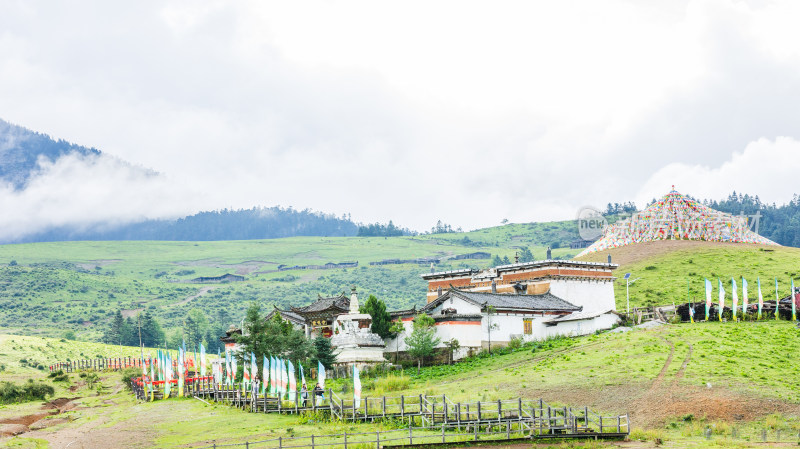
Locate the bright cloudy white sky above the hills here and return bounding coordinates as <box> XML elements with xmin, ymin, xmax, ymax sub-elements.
<box><xmin>0</xmin><ymin>0</ymin><xmax>800</xmax><ymax>236</ymax></box>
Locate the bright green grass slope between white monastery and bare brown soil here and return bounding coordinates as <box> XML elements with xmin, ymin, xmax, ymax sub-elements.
<box><xmin>400</xmin><ymin>321</ymin><xmax>800</xmax><ymax>404</ymax></box>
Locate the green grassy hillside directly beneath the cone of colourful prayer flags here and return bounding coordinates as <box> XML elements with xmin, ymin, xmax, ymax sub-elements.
<box><xmin>582</xmin><ymin>241</ymin><xmax>800</xmax><ymax>310</ymax></box>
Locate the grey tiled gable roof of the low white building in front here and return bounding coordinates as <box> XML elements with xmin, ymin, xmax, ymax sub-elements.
<box><xmin>420</xmin><ymin>289</ymin><xmax>583</xmax><ymax>312</ymax></box>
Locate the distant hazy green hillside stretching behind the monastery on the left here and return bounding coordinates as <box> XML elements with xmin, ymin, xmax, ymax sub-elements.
<box><xmin>0</xmin><ymin>222</ymin><xmax>577</xmax><ymax>340</ymax></box>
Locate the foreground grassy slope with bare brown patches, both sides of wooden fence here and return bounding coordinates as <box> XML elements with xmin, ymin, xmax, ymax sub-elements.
<box><xmin>0</xmin><ymin>321</ymin><xmax>800</xmax><ymax>448</ymax></box>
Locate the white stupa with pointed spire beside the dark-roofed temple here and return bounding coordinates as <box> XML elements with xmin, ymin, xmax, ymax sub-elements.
<box><xmin>331</xmin><ymin>287</ymin><xmax>386</xmax><ymax>365</ymax></box>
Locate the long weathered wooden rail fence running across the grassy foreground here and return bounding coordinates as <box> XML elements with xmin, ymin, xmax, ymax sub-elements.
<box><xmin>133</xmin><ymin>378</ymin><xmax>630</xmax><ymax>442</ymax></box>
